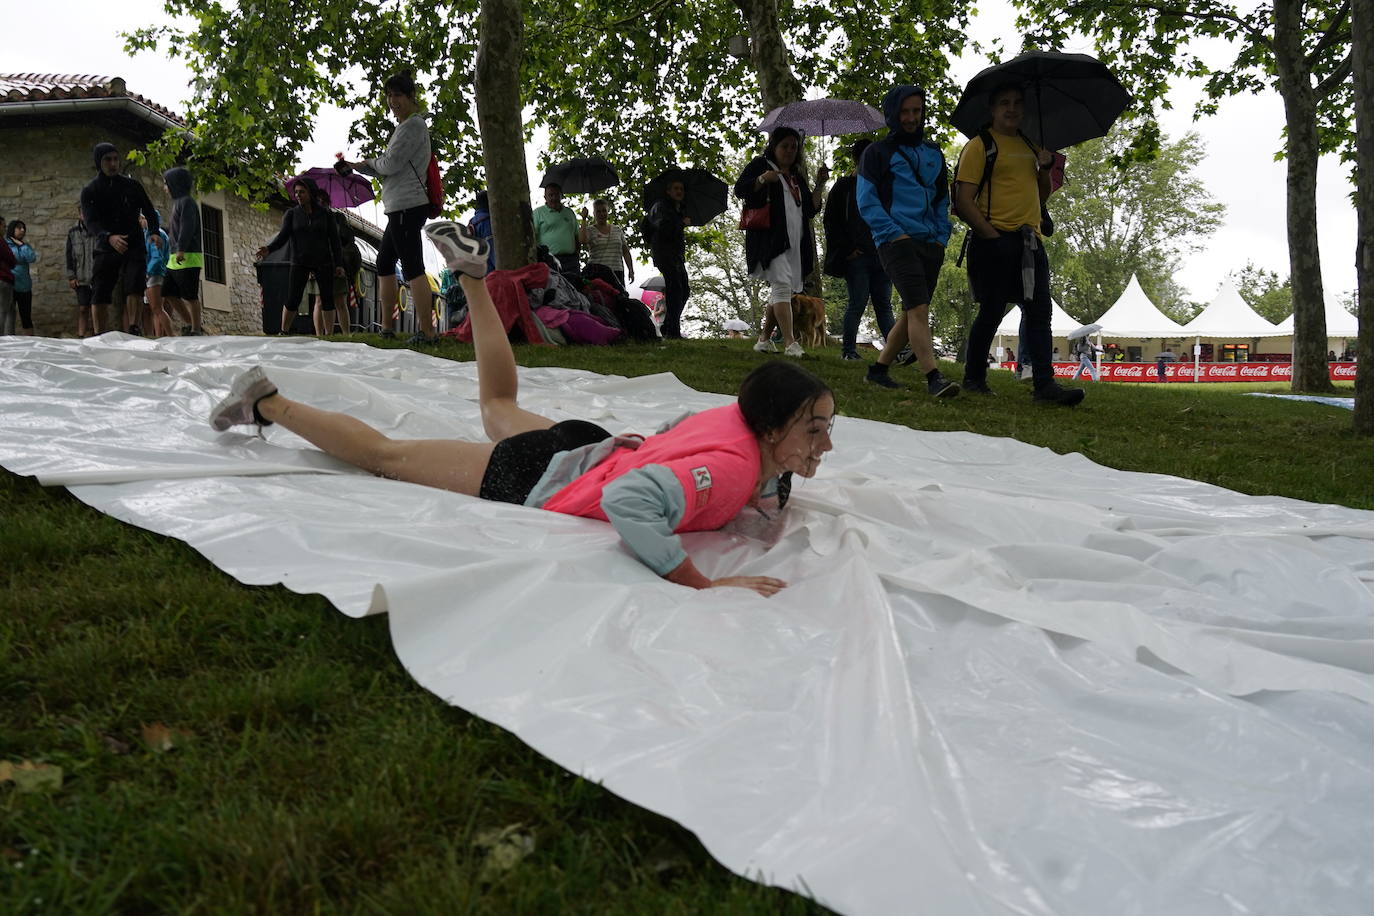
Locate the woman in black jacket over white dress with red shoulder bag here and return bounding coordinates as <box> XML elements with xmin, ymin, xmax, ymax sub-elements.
<box><xmin>735</xmin><ymin>128</ymin><xmax>830</xmax><ymax>356</ymax></box>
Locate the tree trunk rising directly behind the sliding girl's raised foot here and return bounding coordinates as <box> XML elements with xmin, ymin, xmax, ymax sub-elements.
<box><xmin>475</xmin><ymin>0</ymin><xmax>534</xmax><ymax>271</ymax></box>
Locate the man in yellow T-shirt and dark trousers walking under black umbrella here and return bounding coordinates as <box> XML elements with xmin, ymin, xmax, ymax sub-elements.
<box><xmin>954</xmin><ymin>84</ymin><xmax>1083</xmax><ymax>407</ymax></box>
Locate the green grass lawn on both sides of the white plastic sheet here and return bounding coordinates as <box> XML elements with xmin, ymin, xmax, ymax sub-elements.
<box><xmin>0</xmin><ymin>341</ymin><xmax>1374</xmax><ymax>913</ymax></box>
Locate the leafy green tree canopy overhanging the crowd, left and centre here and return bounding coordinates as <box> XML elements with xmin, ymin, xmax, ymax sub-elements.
<box><xmin>128</xmin><ymin>0</ymin><xmax>969</xmax><ymax>207</ymax></box>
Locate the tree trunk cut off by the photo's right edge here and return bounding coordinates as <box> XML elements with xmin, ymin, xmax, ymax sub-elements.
<box><xmin>1351</xmin><ymin>0</ymin><xmax>1374</xmax><ymax>435</ymax></box>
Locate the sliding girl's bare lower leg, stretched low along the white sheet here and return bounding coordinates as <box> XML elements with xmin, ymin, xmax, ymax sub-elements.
<box><xmin>257</xmin><ymin>394</ymin><xmax>496</xmax><ymax>496</ymax></box>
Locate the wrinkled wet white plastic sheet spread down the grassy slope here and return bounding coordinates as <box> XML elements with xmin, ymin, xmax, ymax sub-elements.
<box><xmin>0</xmin><ymin>334</ymin><xmax>1374</xmax><ymax>916</ymax></box>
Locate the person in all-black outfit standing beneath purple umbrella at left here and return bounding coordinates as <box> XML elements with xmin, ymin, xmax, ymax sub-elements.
<box><xmin>257</xmin><ymin>179</ymin><xmax>344</xmax><ymax>336</ymax></box>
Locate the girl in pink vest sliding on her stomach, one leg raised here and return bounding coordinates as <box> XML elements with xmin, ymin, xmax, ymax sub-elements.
<box><xmin>210</xmin><ymin>222</ymin><xmax>835</xmax><ymax>596</ymax></box>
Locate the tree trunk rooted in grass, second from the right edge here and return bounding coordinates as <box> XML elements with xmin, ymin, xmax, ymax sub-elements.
<box><xmin>1274</xmin><ymin>0</ymin><xmax>1333</xmax><ymax>391</ymax></box>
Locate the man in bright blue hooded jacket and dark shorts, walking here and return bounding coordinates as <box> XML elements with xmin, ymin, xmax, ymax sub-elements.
<box><xmin>857</xmin><ymin>85</ymin><xmax>959</xmax><ymax>397</ymax></box>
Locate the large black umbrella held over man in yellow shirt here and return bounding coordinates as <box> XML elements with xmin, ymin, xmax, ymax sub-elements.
<box><xmin>951</xmin><ymin>51</ymin><xmax>1131</xmax><ymax>150</ymax></box>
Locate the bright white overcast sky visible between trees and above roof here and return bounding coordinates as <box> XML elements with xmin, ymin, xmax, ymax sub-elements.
<box><xmin>10</xmin><ymin>0</ymin><xmax>1355</xmax><ymax>302</ymax></box>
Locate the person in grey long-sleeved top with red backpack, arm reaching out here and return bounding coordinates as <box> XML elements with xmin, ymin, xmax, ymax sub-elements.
<box><xmin>339</xmin><ymin>73</ymin><xmax>434</xmax><ymax>345</ymax></box>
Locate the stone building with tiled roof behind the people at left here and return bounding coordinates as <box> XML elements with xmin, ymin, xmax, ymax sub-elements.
<box><xmin>0</xmin><ymin>73</ymin><xmax>381</xmax><ymax>336</ymax></box>
